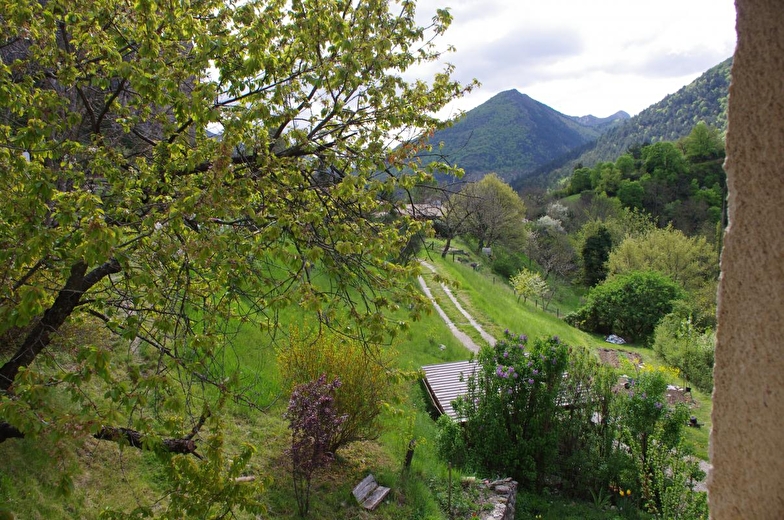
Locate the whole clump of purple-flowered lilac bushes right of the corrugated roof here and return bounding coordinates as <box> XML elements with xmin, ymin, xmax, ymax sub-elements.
<box><xmin>437</xmin><ymin>331</ymin><xmax>707</xmax><ymax>518</ymax></box>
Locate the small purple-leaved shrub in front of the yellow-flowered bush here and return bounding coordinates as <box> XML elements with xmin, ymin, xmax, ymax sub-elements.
<box><xmin>285</xmin><ymin>374</ymin><xmax>346</xmax><ymax>516</ymax></box>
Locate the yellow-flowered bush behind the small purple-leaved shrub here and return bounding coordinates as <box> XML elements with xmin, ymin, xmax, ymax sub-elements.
<box><xmin>278</xmin><ymin>327</ymin><xmax>399</xmax><ymax>452</ymax></box>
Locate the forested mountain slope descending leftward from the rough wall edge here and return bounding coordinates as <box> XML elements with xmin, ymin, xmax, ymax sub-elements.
<box><xmin>511</xmin><ymin>58</ymin><xmax>732</xmax><ymax>190</ymax></box>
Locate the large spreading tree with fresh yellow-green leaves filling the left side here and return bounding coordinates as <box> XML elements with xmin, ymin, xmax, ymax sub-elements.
<box><xmin>0</xmin><ymin>0</ymin><xmax>472</xmax><ymax>506</ymax></box>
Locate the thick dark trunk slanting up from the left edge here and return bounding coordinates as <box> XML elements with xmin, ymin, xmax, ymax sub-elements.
<box><xmin>0</xmin><ymin>258</ymin><xmax>121</xmax><ymax>391</ymax></box>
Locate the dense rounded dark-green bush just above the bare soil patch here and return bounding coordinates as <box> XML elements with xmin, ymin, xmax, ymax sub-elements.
<box><xmin>566</xmin><ymin>271</ymin><xmax>682</xmax><ymax>340</ymax></box>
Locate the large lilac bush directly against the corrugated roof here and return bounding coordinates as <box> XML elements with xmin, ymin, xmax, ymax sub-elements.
<box><xmin>454</xmin><ymin>331</ymin><xmax>615</xmax><ymax>497</ymax></box>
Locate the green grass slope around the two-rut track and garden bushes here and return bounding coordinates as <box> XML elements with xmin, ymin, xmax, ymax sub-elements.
<box><xmin>0</xmin><ymin>238</ymin><xmax>711</xmax><ymax>520</ymax></box>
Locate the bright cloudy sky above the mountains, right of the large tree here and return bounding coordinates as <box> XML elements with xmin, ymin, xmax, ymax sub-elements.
<box><xmin>417</xmin><ymin>0</ymin><xmax>736</xmax><ymax>117</ymax></box>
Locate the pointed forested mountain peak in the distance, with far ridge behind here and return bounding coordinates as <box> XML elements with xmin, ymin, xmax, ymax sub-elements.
<box><xmin>422</xmin><ymin>90</ymin><xmax>629</xmax><ymax>181</ymax></box>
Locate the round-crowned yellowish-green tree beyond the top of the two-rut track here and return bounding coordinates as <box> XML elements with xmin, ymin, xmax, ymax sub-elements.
<box><xmin>459</xmin><ymin>173</ymin><xmax>525</xmax><ymax>249</ymax></box>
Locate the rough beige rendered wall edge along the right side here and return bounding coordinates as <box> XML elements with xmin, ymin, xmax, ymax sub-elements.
<box><xmin>708</xmin><ymin>0</ymin><xmax>784</xmax><ymax>520</ymax></box>
